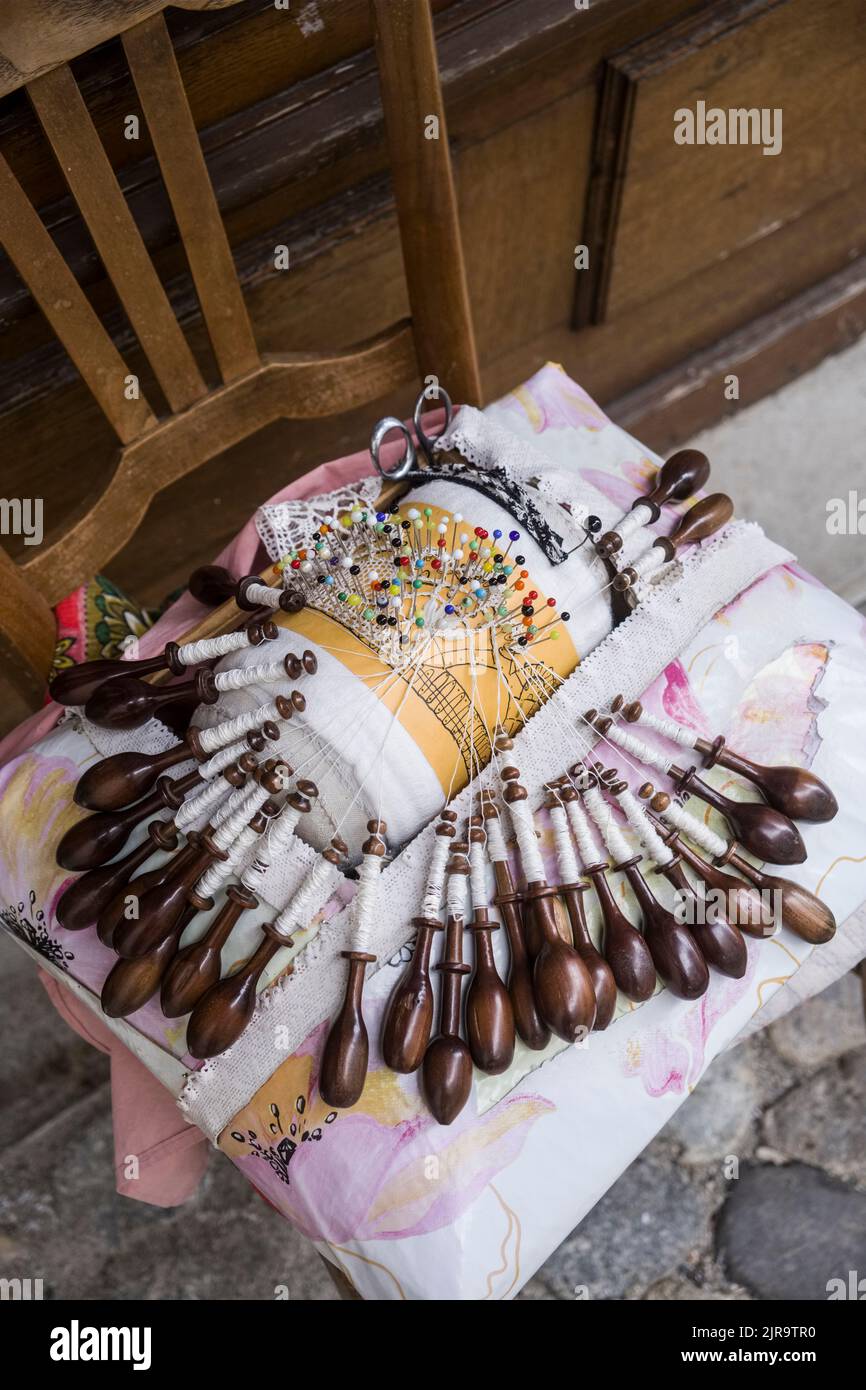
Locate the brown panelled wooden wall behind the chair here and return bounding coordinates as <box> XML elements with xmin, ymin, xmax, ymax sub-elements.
<box><xmin>0</xmin><ymin>0</ymin><xmax>866</xmax><ymax>728</ymax></box>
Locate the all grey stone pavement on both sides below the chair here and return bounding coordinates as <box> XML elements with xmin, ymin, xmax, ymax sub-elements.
<box><xmin>0</xmin><ymin>922</ymin><xmax>866</xmax><ymax>1300</ymax></box>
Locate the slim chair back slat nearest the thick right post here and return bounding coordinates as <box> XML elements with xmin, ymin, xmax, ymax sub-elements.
<box><xmin>122</xmin><ymin>14</ymin><xmax>259</xmax><ymax>382</ymax></box>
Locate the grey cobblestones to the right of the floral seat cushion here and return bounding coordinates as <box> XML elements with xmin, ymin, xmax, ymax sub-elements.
<box><xmin>521</xmin><ymin>974</ymin><xmax>866</xmax><ymax>1300</ymax></box>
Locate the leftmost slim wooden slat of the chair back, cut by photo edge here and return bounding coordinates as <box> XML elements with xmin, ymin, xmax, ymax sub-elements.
<box><xmin>0</xmin><ymin>154</ymin><xmax>156</xmax><ymax>443</ymax></box>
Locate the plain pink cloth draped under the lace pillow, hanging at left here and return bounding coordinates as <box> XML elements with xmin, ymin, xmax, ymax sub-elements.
<box><xmin>0</xmin><ymin>411</ymin><xmax>442</xmax><ymax>1207</ymax></box>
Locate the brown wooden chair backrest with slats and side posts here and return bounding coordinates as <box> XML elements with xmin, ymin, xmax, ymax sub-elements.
<box><xmin>0</xmin><ymin>0</ymin><xmax>481</xmax><ymax>691</ymax></box>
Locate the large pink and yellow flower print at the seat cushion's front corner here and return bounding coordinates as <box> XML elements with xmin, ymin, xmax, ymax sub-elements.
<box><xmin>220</xmin><ymin>1023</ymin><xmax>555</xmax><ymax>1243</ymax></box>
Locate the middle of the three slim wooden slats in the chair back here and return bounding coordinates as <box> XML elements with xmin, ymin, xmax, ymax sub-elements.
<box><xmin>28</xmin><ymin>64</ymin><xmax>207</xmax><ymax>410</ymax></box>
